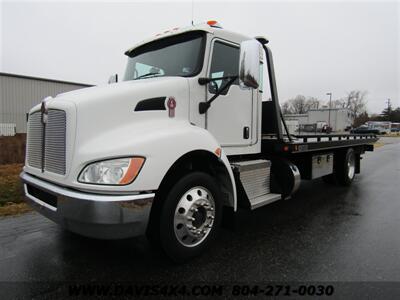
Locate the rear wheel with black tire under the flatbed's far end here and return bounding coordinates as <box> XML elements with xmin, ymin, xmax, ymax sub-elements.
<box><xmin>335</xmin><ymin>148</ymin><xmax>356</xmax><ymax>186</ymax></box>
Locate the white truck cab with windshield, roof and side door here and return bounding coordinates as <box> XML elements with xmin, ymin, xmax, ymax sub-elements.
<box><xmin>124</xmin><ymin>24</ymin><xmax>263</xmax><ymax>155</ymax></box>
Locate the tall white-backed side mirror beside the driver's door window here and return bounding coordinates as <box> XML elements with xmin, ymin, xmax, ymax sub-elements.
<box><xmin>239</xmin><ymin>40</ymin><xmax>260</xmax><ymax>89</ymax></box>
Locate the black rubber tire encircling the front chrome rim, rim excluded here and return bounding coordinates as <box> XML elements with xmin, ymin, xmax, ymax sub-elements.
<box><xmin>159</xmin><ymin>172</ymin><xmax>222</xmax><ymax>263</ymax></box>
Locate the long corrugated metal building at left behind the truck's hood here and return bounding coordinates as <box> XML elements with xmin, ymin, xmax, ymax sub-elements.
<box><xmin>0</xmin><ymin>72</ymin><xmax>90</xmax><ymax>133</ymax></box>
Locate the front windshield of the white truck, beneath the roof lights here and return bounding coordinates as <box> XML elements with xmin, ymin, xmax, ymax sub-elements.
<box><xmin>124</xmin><ymin>31</ymin><xmax>205</xmax><ymax>81</ymax></box>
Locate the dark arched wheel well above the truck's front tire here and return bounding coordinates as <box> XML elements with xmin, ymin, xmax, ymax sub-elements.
<box><xmin>147</xmin><ymin>150</ymin><xmax>234</xmax><ymax>238</ymax></box>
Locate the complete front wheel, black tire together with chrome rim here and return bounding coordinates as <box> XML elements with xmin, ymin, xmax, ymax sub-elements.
<box><xmin>159</xmin><ymin>172</ymin><xmax>222</xmax><ymax>262</ymax></box>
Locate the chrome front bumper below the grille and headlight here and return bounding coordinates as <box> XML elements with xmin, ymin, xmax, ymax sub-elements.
<box><xmin>20</xmin><ymin>172</ymin><xmax>155</xmax><ymax>239</ymax></box>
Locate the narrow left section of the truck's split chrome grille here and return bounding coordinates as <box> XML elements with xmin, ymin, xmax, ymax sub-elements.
<box><xmin>27</xmin><ymin>112</ymin><xmax>43</xmax><ymax>169</ymax></box>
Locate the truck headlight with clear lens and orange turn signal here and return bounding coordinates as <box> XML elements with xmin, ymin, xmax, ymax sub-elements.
<box><xmin>78</xmin><ymin>157</ymin><xmax>145</xmax><ymax>185</ymax></box>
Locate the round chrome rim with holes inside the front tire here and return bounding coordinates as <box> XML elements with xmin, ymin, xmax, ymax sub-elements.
<box><xmin>174</xmin><ymin>186</ymin><xmax>215</xmax><ymax>247</ymax></box>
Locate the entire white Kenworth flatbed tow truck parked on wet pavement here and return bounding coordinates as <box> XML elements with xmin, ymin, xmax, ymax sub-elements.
<box><xmin>21</xmin><ymin>21</ymin><xmax>377</xmax><ymax>262</ymax></box>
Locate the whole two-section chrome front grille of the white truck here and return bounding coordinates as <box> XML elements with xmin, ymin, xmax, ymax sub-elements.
<box><xmin>27</xmin><ymin>109</ymin><xmax>67</xmax><ymax>175</ymax></box>
